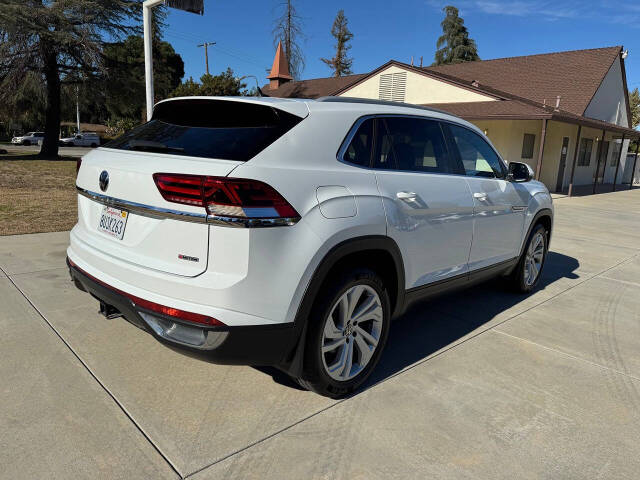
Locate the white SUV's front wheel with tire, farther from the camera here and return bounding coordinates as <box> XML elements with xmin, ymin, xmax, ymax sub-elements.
<box><xmin>509</xmin><ymin>224</ymin><xmax>549</xmax><ymax>293</ymax></box>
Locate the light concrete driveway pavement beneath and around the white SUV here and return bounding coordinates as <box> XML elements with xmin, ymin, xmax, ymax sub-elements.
<box><xmin>0</xmin><ymin>190</ymin><xmax>640</xmax><ymax>479</ymax></box>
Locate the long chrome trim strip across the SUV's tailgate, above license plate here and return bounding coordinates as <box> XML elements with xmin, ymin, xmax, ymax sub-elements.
<box><xmin>76</xmin><ymin>186</ymin><xmax>300</xmax><ymax>228</ymax></box>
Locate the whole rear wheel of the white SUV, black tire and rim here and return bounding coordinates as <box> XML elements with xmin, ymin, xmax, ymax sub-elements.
<box><xmin>298</xmin><ymin>268</ymin><xmax>391</xmax><ymax>398</ymax></box>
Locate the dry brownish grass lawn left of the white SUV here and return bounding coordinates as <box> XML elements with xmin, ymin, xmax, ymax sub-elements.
<box><xmin>0</xmin><ymin>161</ymin><xmax>78</xmax><ymax>235</ymax></box>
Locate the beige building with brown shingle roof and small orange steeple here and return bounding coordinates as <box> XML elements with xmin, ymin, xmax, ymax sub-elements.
<box><xmin>263</xmin><ymin>47</ymin><xmax>640</xmax><ymax>192</ymax></box>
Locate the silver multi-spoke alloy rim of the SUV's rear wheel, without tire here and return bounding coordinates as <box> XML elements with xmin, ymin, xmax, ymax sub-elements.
<box><xmin>322</xmin><ymin>285</ymin><xmax>384</xmax><ymax>382</ymax></box>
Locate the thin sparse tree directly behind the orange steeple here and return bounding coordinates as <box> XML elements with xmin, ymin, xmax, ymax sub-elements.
<box><xmin>273</xmin><ymin>0</ymin><xmax>305</xmax><ymax>79</ymax></box>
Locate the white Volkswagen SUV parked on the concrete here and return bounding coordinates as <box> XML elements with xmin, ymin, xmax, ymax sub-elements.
<box><xmin>68</xmin><ymin>97</ymin><xmax>553</xmax><ymax>397</ymax></box>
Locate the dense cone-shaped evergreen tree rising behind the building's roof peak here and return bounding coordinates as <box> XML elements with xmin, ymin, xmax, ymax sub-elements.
<box><xmin>433</xmin><ymin>5</ymin><xmax>480</xmax><ymax>65</ymax></box>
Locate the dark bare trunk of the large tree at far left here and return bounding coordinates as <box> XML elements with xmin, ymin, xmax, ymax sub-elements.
<box><xmin>40</xmin><ymin>47</ymin><xmax>60</xmax><ymax>159</ymax></box>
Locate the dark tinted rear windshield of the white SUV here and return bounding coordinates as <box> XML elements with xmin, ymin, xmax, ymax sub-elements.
<box><xmin>105</xmin><ymin>99</ymin><xmax>302</xmax><ymax>162</ymax></box>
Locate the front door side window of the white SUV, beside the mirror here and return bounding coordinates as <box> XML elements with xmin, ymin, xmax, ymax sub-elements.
<box><xmin>449</xmin><ymin>125</ymin><xmax>504</xmax><ymax>178</ymax></box>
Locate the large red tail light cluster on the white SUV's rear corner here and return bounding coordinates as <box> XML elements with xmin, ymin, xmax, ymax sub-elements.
<box><xmin>153</xmin><ymin>173</ymin><xmax>300</xmax><ymax>219</ymax></box>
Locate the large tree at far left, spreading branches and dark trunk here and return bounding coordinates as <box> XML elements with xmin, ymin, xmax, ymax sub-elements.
<box><xmin>0</xmin><ymin>0</ymin><xmax>141</xmax><ymax>158</ymax></box>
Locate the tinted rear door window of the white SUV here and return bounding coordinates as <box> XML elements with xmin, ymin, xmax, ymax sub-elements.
<box><xmin>374</xmin><ymin>117</ymin><xmax>450</xmax><ymax>173</ymax></box>
